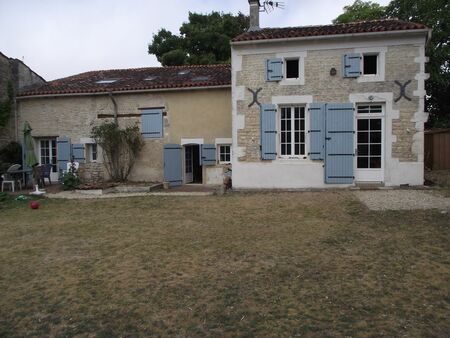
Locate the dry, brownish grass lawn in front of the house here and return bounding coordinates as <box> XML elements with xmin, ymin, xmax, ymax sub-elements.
<box><xmin>0</xmin><ymin>191</ymin><xmax>450</xmax><ymax>337</ymax></box>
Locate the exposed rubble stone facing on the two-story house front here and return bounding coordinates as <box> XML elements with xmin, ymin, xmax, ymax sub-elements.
<box><xmin>236</xmin><ymin>45</ymin><xmax>423</xmax><ymax>162</ymax></box>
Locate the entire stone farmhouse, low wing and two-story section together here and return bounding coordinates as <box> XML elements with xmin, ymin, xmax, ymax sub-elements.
<box><xmin>13</xmin><ymin>0</ymin><xmax>430</xmax><ymax>189</ymax></box>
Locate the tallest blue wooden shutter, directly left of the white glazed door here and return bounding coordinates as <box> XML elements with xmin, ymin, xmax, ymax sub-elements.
<box><xmin>325</xmin><ymin>103</ymin><xmax>355</xmax><ymax>184</ymax></box>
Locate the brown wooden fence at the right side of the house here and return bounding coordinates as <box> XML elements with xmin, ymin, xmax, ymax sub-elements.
<box><xmin>425</xmin><ymin>129</ymin><xmax>450</xmax><ymax>170</ymax></box>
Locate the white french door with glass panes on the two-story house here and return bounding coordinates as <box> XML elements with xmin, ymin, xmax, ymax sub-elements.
<box><xmin>355</xmin><ymin>103</ymin><xmax>385</xmax><ymax>182</ymax></box>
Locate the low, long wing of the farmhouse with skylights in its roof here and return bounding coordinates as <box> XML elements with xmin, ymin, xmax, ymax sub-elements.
<box><xmin>18</xmin><ymin>65</ymin><xmax>231</xmax><ymax>186</ymax></box>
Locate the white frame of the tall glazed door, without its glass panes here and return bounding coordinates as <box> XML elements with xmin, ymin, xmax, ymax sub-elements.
<box><xmin>354</xmin><ymin>102</ymin><xmax>386</xmax><ymax>182</ymax></box>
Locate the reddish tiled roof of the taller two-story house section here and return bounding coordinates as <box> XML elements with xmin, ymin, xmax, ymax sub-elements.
<box><xmin>232</xmin><ymin>19</ymin><xmax>427</xmax><ymax>42</ymax></box>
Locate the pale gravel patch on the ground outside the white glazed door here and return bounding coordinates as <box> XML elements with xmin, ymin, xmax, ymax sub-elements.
<box><xmin>354</xmin><ymin>190</ymin><xmax>450</xmax><ymax>210</ymax></box>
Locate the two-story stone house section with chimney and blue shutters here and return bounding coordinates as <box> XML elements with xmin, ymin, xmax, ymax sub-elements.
<box><xmin>231</xmin><ymin>0</ymin><xmax>430</xmax><ymax>189</ymax></box>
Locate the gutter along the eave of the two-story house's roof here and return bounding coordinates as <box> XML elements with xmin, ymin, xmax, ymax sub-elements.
<box><xmin>230</xmin><ymin>28</ymin><xmax>431</xmax><ymax>46</ymax></box>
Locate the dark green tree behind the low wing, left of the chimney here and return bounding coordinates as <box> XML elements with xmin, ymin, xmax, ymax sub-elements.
<box><xmin>148</xmin><ymin>12</ymin><xmax>249</xmax><ymax>66</ymax></box>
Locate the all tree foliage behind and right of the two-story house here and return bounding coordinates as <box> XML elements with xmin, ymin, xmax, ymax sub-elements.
<box><xmin>333</xmin><ymin>0</ymin><xmax>450</xmax><ymax>127</ymax></box>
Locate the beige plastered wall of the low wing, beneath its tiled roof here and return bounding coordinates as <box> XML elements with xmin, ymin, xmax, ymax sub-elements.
<box><xmin>18</xmin><ymin>88</ymin><xmax>231</xmax><ymax>181</ymax></box>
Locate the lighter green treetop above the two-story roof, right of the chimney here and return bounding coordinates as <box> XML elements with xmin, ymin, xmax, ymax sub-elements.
<box><xmin>333</xmin><ymin>0</ymin><xmax>386</xmax><ymax>23</ymax></box>
